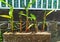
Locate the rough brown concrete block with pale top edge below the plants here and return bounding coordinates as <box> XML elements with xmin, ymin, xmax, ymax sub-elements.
<box><xmin>3</xmin><ymin>32</ymin><xmax>51</xmax><ymax>42</ymax></box>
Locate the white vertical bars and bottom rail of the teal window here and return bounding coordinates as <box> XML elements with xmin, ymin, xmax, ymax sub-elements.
<box><xmin>0</xmin><ymin>0</ymin><xmax>60</xmax><ymax>10</ymax></box>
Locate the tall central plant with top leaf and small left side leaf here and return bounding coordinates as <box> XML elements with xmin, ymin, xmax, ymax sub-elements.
<box><xmin>19</xmin><ymin>0</ymin><xmax>35</xmax><ymax>32</ymax></box>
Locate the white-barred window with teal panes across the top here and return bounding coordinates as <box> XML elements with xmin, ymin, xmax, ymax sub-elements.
<box><xmin>0</xmin><ymin>0</ymin><xmax>60</xmax><ymax>10</ymax></box>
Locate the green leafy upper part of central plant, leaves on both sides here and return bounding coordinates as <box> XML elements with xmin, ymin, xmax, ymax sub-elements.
<box><xmin>19</xmin><ymin>0</ymin><xmax>36</xmax><ymax>20</ymax></box>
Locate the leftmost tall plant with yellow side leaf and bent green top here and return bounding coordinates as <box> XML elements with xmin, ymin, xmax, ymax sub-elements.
<box><xmin>0</xmin><ymin>0</ymin><xmax>13</xmax><ymax>32</ymax></box>
